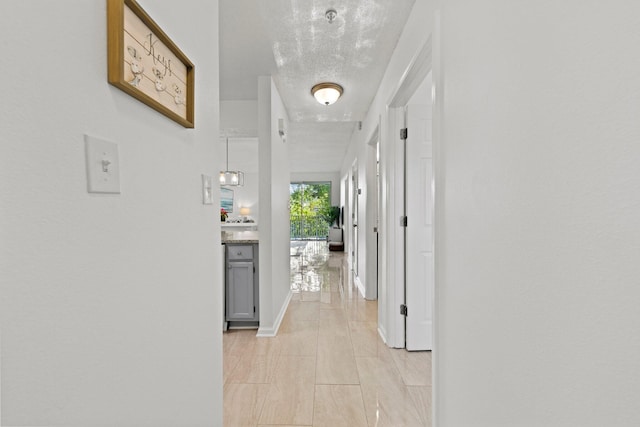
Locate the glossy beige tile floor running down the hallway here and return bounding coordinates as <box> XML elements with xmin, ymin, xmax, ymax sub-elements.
<box><xmin>224</xmin><ymin>242</ymin><xmax>431</xmax><ymax>427</ymax></box>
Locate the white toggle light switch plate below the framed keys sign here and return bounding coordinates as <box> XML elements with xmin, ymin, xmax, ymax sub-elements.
<box><xmin>84</xmin><ymin>135</ymin><xmax>120</xmax><ymax>194</ymax></box>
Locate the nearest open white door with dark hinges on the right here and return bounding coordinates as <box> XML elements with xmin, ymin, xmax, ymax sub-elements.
<box><xmin>405</xmin><ymin>100</ymin><xmax>434</xmax><ymax>350</ymax></box>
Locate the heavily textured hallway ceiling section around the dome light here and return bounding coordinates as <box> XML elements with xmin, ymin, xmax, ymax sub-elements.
<box><xmin>260</xmin><ymin>0</ymin><xmax>413</xmax><ymax>122</ymax></box>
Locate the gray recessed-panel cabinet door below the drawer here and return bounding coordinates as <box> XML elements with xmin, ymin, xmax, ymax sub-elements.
<box><xmin>226</xmin><ymin>261</ymin><xmax>256</xmax><ymax>320</ymax></box>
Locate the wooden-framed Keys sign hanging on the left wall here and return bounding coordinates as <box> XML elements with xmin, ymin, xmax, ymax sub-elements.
<box><xmin>107</xmin><ymin>0</ymin><xmax>195</xmax><ymax>128</ymax></box>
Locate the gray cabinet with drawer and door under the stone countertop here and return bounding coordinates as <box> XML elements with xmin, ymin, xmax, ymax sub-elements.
<box><xmin>225</xmin><ymin>244</ymin><xmax>260</xmax><ymax>322</ymax></box>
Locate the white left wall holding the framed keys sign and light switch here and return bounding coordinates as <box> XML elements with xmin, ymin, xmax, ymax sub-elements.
<box><xmin>0</xmin><ymin>0</ymin><xmax>222</xmax><ymax>426</ymax></box>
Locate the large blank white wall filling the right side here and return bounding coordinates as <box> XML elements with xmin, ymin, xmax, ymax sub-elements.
<box><xmin>435</xmin><ymin>0</ymin><xmax>640</xmax><ymax>427</ymax></box>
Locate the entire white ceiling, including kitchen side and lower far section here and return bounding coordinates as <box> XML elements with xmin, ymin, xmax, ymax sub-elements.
<box><xmin>220</xmin><ymin>0</ymin><xmax>415</xmax><ymax>172</ymax></box>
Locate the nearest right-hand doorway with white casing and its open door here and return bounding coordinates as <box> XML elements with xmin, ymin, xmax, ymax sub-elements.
<box><xmin>383</xmin><ymin>37</ymin><xmax>436</xmax><ymax>351</ymax></box>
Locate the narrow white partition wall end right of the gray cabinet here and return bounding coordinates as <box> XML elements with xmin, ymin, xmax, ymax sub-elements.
<box><xmin>258</xmin><ymin>76</ymin><xmax>291</xmax><ymax>336</ymax></box>
